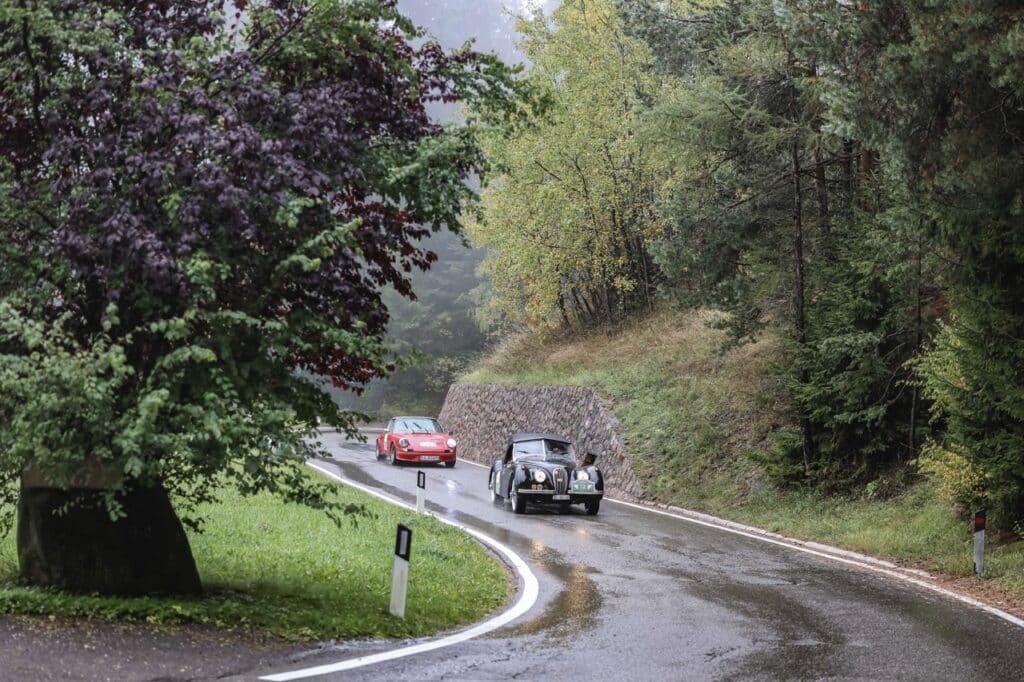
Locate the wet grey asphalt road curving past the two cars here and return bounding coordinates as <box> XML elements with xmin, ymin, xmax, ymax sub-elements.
<box><xmin>253</xmin><ymin>434</ymin><xmax>1024</xmax><ymax>681</ymax></box>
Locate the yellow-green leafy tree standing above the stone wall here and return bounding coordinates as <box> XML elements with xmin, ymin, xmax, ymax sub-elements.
<box><xmin>469</xmin><ymin>0</ymin><xmax>662</xmax><ymax>327</ymax></box>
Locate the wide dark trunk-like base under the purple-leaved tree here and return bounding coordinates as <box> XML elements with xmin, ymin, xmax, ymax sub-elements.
<box><xmin>17</xmin><ymin>476</ymin><xmax>202</xmax><ymax>595</ymax></box>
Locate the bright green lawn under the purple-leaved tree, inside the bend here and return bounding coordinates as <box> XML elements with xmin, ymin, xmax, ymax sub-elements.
<box><xmin>0</xmin><ymin>473</ymin><xmax>509</xmax><ymax>639</ymax></box>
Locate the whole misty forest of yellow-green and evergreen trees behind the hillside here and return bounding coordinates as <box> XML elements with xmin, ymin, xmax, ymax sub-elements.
<box><xmin>344</xmin><ymin>0</ymin><xmax>1024</xmax><ymax>530</ymax></box>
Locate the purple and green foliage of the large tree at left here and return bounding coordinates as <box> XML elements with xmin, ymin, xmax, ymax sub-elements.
<box><xmin>0</xmin><ymin>0</ymin><xmax>519</xmax><ymax>522</ymax></box>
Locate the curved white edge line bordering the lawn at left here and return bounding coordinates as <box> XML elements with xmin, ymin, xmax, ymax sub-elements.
<box><xmin>259</xmin><ymin>463</ymin><xmax>540</xmax><ymax>682</ymax></box>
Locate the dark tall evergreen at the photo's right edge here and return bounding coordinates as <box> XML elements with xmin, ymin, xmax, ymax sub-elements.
<box><xmin>786</xmin><ymin>0</ymin><xmax>1024</xmax><ymax>520</ymax></box>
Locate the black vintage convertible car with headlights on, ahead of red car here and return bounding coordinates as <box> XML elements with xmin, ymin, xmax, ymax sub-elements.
<box><xmin>487</xmin><ymin>433</ymin><xmax>604</xmax><ymax>515</ymax></box>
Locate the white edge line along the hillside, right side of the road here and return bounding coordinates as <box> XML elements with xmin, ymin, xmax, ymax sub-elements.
<box><xmin>460</xmin><ymin>460</ymin><xmax>1024</xmax><ymax>628</ymax></box>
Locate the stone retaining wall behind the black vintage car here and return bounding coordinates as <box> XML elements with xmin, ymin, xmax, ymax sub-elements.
<box><xmin>439</xmin><ymin>384</ymin><xmax>643</xmax><ymax>500</ymax></box>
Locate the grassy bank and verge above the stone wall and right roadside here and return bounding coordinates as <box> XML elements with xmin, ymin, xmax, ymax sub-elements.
<box><xmin>462</xmin><ymin>311</ymin><xmax>1024</xmax><ymax>599</ymax></box>
